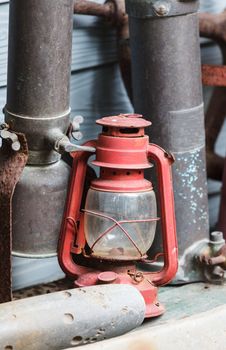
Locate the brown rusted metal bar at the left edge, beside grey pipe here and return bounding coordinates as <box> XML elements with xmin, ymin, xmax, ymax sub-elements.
<box><xmin>0</xmin><ymin>133</ymin><xmax>28</xmax><ymax>303</ymax></box>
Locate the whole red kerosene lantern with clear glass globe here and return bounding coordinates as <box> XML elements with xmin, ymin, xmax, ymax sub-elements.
<box><xmin>58</xmin><ymin>114</ymin><xmax>177</xmax><ymax>317</ymax></box>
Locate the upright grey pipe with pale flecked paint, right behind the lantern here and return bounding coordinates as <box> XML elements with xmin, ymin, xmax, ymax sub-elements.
<box><xmin>126</xmin><ymin>0</ymin><xmax>209</xmax><ymax>283</ymax></box>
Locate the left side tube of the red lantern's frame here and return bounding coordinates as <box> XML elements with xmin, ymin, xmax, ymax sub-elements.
<box><xmin>58</xmin><ymin>140</ymin><xmax>96</xmax><ymax>277</ymax></box>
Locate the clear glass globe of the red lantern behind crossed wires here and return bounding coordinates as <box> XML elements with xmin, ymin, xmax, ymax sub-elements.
<box><xmin>84</xmin><ymin>188</ymin><xmax>157</xmax><ymax>261</ymax></box>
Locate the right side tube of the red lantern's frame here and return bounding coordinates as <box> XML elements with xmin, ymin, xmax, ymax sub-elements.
<box><xmin>147</xmin><ymin>144</ymin><xmax>178</xmax><ymax>285</ymax></box>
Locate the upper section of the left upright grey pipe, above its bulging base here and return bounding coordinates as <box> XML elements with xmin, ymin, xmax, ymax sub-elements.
<box><xmin>5</xmin><ymin>0</ymin><xmax>73</xmax><ymax>164</ymax></box>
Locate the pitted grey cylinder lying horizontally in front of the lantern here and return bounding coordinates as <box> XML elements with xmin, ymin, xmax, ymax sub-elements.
<box><xmin>0</xmin><ymin>285</ymin><xmax>145</xmax><ymax>350</ymax></box>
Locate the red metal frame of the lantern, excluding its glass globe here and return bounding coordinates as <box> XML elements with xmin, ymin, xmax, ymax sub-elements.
<box><xmin>58</xmin><ymin>114</ymin><xmax>178</xmax><ymax>317</ymax></box>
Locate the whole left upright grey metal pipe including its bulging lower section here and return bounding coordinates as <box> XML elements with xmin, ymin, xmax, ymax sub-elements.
<box><xmin>5</xmin><ymin>0</ymin><xmax>73</xmax><ymax>257</ymax></box>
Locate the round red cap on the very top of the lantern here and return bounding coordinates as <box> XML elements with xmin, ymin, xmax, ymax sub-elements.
<box><xmin>96</xmin><ymin>114</ymin><xmax>152</xmax><ymax>129</ymax></box>
